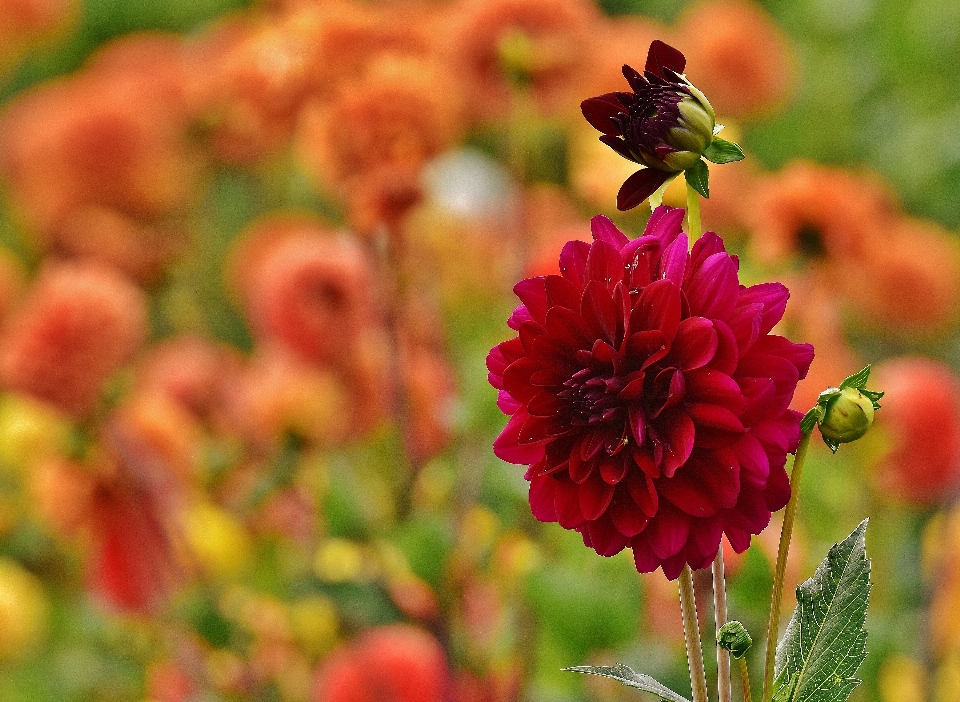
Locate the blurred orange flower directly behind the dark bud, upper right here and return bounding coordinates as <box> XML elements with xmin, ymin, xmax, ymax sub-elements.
<box><xmin>677</xmin><ymin>0</ymin><xmax>797</xmax><ymax>119</ymax></box>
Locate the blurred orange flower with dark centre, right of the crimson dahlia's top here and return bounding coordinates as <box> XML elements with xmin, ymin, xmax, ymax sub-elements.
<box><xmin>745</xmin><ymin>161</ymin><xmax>898</xmax><ymax>265</ymax></box>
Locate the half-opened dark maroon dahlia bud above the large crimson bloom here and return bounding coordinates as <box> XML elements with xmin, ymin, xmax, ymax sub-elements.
<box><xmin>580</xmin><ymin>40</ymin><xmax>720</xmax><ymax>210</ymax></box>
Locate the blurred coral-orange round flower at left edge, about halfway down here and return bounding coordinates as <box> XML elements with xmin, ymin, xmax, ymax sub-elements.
<box><xmin>0</xmin><ymin>264</ymin><xmax>147</xmax><ymax>415</ymax></box>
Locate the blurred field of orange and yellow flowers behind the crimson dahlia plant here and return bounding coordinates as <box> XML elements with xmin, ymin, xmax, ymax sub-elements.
<box><xmin>0</xmin><ymin>0</ymin><xmax>960</xmax><ymax>702</ymax></box>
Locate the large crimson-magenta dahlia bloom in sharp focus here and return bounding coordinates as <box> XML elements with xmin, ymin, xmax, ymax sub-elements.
<box><xmin>487</xmin><ymin>207</ymin><xmax>813</xmax><ymax>579</ymax></box>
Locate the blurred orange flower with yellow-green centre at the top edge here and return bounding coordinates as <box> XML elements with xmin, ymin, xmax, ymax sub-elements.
<box><xmin>449</xmin><ymin>0</ymin><xmax>599</xmax><ymax>120</ymax></box>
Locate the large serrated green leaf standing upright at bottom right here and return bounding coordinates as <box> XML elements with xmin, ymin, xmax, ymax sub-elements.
<box><xmin>773</xmin><ymin>520</ymin><xmax>870</xmax><ymax>702</ymax></box>
